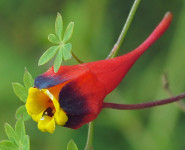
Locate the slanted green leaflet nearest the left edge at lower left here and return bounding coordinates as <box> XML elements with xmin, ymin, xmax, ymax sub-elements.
<box><xmin>4</xmin><ymin>123</ymin><xmax>18</xmax><ymax>144</ymax></box>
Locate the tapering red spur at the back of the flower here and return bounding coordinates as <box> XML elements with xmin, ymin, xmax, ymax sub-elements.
<box><xmin>87</xmin><ymin>12</ymin><xmax>172</xmax><ymax>93</ymax></box>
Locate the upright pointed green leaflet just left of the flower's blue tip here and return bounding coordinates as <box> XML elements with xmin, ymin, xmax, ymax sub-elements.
<box><xmin>23</xmin><ymin>68</ymin><xmax>34</xmax><ymax>90</ymax></box>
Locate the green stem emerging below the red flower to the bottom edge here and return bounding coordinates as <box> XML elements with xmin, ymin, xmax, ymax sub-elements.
<box><xmin>85</xmin><ymin>122</ymin><xmax>94</xmax><ymax>150</ymax></box>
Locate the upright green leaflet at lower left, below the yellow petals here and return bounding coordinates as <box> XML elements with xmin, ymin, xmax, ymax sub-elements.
<box><xmin>15</xmin><ymin>118</ymin><xmax>25</xmax><ymax>145</ymax></box>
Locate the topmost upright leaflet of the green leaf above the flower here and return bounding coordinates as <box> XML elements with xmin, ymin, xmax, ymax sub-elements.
<box><xmin>55</xmin><ymin>13</ymin><xmax>63</xmax><ymax>41</ymax></box>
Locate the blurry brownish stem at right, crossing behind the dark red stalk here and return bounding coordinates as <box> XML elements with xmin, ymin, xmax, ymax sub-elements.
<box><xmin>162</xmin><ymin>73</ymin><xmax>185</xmax><ymax>112</ymax></box>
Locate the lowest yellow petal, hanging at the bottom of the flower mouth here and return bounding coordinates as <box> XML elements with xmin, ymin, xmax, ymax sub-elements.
<box><xmin>38</xmin><ymin>116</ymin><xmax>55</xmax><ymax>133</ymax></box>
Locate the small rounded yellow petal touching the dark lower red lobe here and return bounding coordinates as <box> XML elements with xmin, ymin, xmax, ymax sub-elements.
<box><xmin>54</xmin><ymin>109</ymin><xmax>68</xmax><ymax>126</ymax></box>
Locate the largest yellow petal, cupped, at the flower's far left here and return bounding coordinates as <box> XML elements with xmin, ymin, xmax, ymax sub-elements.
<box><xmin>26</xmin><ymin>87</ymin><xmax>50</xmax><ymax>115</ymax></box>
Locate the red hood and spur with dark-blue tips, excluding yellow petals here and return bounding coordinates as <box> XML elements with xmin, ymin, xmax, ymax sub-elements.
<box><xmin>26</xmin><ymin>13</ymin><xmax>172</xmax><ymax>129</ymax></box>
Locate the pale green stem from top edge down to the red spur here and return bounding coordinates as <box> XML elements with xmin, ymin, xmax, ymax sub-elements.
<box><xmin>107</xmin><ymin>0</ymin><xmax>141</xmax><ymax>59</ymax></box>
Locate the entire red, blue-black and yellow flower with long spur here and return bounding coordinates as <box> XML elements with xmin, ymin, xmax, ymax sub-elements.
<box><xmin>26</xmin><ymin>12</ymin><xmax>172</xmax><ymax>133</ymax></box>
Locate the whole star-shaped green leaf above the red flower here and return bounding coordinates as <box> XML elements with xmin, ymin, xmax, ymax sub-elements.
<box><xmin>38</xmin><ymin>13</ymin><xmax>74</xmax><ymax>72</ymax></box>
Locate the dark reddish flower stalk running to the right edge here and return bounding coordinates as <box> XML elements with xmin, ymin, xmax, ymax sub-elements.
<box><xmin>103</xmin><ymin>93</ymin><xmax>185</xmax><ymax>110</ymax></box>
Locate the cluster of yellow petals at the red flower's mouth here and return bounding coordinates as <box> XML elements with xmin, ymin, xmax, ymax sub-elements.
<box><xmin>26</xmin><ymin>87</ymin><xmax>68</xmax><ymax>133</ymax></box>
